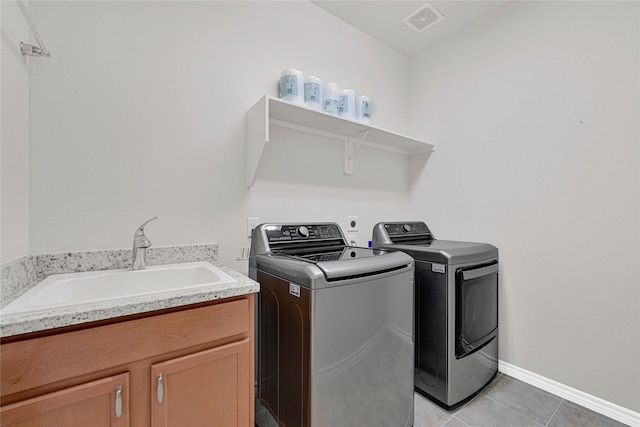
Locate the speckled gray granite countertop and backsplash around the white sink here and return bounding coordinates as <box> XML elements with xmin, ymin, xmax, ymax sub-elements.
<box><xmin>0</xmin><ymin>245</ymin><xmax>260</xmax><ymax>338</ymax></box>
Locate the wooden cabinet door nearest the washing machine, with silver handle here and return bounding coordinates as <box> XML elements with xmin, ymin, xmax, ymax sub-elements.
<box><xmin>151</xmin><ymin>338</ymin><xmax>253</xmax><ymax>427</ymax></box>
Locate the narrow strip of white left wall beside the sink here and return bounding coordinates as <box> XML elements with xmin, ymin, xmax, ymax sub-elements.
<box><xmin>0</xmin><ymin>1</ymin><xmax>31</xmax><ymax>263</ymax></box>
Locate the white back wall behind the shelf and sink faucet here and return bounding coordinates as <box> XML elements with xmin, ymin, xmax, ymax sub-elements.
<box><xmin>31</xmin><ymin>1</ymin><xmax>409</xmax><ymax>264</ymax></box>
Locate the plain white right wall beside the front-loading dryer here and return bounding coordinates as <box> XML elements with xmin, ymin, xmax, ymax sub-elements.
<box><xmin>411</xmin><ymin>2</ymin><xmax>640</xmax><ymax>411</ymax></box>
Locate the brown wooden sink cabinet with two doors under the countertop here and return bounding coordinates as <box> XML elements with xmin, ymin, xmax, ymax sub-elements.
<box><xmin>0</xmin><ymin>294</ymin><xmax>254</xmax><ymax>427</ymax></box>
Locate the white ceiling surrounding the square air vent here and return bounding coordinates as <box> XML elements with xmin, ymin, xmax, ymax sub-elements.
<box><xmin>310</xmin><ymin>0</ymin><xmax>507</xmax><ymax>57</ymax></box>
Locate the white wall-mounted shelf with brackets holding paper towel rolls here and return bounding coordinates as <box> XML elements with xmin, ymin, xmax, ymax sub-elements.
<box><xmin>247</xmin><ymin>95</ymin><xmax>435</xmax><ymax>187</ymax></box>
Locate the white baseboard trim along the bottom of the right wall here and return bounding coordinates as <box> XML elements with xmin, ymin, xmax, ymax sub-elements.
<box><xmin>498</xmin><ymin>360</ymin><xmax>640</xmax><ymax>427</ymax></box>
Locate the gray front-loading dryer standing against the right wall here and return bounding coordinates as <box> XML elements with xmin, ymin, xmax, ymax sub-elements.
<box><xmin>372</xmin><ymin>222</ymin><xmax>498</xmax><ymax>409</ymax></box>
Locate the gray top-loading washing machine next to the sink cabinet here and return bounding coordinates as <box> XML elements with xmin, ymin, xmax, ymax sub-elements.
<box><xmin>249</xmin><ymin>223</ymin><xmax>414</xmax><ymax>427</ymax></box>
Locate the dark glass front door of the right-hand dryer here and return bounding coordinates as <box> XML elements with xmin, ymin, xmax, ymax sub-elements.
<box><xmin>456</xmin><ymin>261</ymin><xmax>498</xmax><ymax>359</ymax></box>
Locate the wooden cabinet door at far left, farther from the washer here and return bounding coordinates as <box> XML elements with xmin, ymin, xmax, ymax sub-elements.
<box><xmin>0</xmin><ymin>373</ymin><xmax>129</xmax><ymax>427</ymax></box>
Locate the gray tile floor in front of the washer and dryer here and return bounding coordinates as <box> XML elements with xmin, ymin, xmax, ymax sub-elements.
<box><xmin>256</xmin><ymin>374</ymin><xmax>625</xmax><ymax>427</ymax></box>
